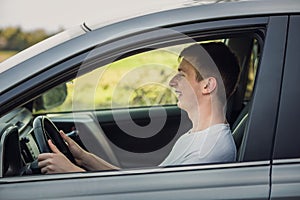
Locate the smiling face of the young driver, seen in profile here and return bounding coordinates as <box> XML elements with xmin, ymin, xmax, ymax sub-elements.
<box><xmin>169</xmin><ymin>59</ymin><xmax>203</xmax><ymax>111</ymax></box>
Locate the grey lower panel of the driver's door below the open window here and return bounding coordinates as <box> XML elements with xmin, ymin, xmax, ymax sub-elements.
<box><xmin>0</xmin><ymin>162</ymin><xmax>270</xmax><ymax>200</ymax></box>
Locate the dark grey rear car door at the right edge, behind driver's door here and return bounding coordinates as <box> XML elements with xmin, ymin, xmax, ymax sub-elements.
<box><xmin>271</xmin><ymin>15</ymin><xmax>300</xmax><ymax>199</ymax></box>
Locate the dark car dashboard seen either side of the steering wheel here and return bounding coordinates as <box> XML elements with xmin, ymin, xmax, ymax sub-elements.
<box><xmin>0</xmin><ymin>107</ymin><xmax>86</xmax><ymax>176</ymax></box>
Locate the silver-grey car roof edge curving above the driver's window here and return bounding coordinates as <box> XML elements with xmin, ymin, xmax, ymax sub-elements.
<box><xmin>0</xmin><ymin>0</ymin><xmax>300</xmax><ymax>94</ymax></box>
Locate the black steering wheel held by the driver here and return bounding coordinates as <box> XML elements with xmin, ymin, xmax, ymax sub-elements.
<box><xmin>33</xmin><ymin>116</ymin><xmax>76</xmax><ymax>164</ymax></box>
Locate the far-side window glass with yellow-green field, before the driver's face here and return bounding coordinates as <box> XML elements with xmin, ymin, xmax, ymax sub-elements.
<box><xmin>74</xmin><ymin>49</ymin><xmax>178</xmax><ymax>109</ymax></box>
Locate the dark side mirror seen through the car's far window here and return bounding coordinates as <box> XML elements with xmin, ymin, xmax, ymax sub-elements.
<box><xmin>33</xmin><ymin>83</ymin><xmax>68</xmax><ymax>111</ymax></box>
